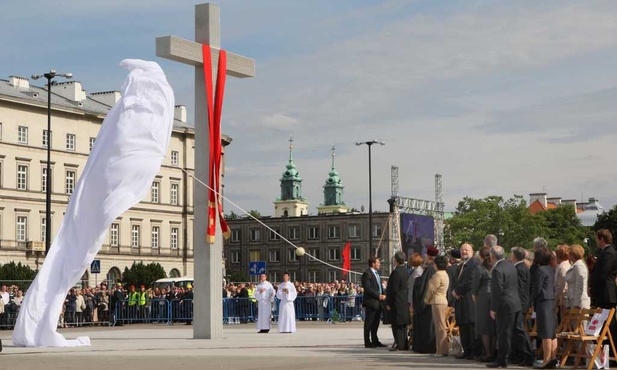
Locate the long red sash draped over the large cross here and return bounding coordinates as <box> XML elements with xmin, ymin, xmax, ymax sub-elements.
<box><xmin>201</xmin><ymin>44</ymin><xmax>231</xmax><ymax>244</ymax></box>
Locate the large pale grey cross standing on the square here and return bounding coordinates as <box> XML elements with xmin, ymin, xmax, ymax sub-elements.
<box><xmin>156</xmin><ymin>4</ymin><xmax>255</xmax><ymax>339</ymax></box>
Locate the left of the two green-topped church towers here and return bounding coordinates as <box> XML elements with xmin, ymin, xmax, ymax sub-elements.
<box><xmin>274</xmin><ymin>137</ymin><xmax>308</xmax><ymax>217</ymax></box>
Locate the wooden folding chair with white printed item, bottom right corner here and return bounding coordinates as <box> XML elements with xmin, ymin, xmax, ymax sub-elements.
<box><xmin>560</xmin><ymin>308</ymin><xmax>616</xmax><ymax>370</ymax></box>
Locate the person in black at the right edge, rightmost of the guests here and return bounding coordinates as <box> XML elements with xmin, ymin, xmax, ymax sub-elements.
<box><xmin>589</xmin><ymin>229</ymin><xmax>617</xmax><ymax>309</ymax></box>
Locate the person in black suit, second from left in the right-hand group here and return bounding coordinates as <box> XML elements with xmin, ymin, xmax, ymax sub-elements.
<box><xmin>386</xmin><ymin>251</ymin><xmax>409</xmax><ymax>351</ymax></box>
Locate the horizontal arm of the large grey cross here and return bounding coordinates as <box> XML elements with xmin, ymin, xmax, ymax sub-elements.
<box><xmin>156</xmin><ymin>36</ymin><xmax>255</xmax><ymax>78</ymax></box>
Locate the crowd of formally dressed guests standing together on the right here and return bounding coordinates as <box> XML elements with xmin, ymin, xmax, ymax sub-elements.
<box><xmin>362</xmin><ymin>229</ymin><xmax>617</xmax><ymax>369</ymax></box>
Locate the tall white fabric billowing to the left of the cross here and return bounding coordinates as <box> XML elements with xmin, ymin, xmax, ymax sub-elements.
<box><xmin>13</xmin><ymin>59</ymin><xmax>174</xmax><ymax>347</ymax></box>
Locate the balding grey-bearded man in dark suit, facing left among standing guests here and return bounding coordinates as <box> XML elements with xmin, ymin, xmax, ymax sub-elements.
<box><xmin>452</xmin><ymin>243</ymin><xmax>478</xmax><ymax>360</ymax></box>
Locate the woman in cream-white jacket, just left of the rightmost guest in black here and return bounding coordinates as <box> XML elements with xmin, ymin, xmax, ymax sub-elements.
<box><xmin>566</xmin><ymin>245</ymin><xmax>591</xmax><ymax>308</ymax></box>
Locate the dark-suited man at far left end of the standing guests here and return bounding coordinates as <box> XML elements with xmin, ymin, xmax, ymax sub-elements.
<box><xmin>362</xmin><ymin>256</ymin><xmax>386</xmax><ymax>348</ymax></box>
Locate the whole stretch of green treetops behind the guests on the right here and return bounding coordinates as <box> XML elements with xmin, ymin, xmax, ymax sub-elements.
<box><xmin>445</xmin><ymin>195</ymin><xmax>588</xmax><ymax>250</ymax></box>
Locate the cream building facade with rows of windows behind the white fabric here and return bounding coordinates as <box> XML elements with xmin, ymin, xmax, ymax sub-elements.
<box><xmin>0</xmin><ymin>76</ymin><xmax>197</xmax><ymax>285</ymax></box>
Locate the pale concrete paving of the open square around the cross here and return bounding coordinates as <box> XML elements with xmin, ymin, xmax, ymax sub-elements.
<box><xmin>0</xmin><ymin>322</ymin><xmax>520</xmax><ymax>370</ymax></box>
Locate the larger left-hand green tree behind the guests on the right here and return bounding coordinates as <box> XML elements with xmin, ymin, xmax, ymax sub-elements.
<box><xmin>446</xmin><ymin>195</ymin><xmax>541</xmax><ymax>250</ymax></box>
